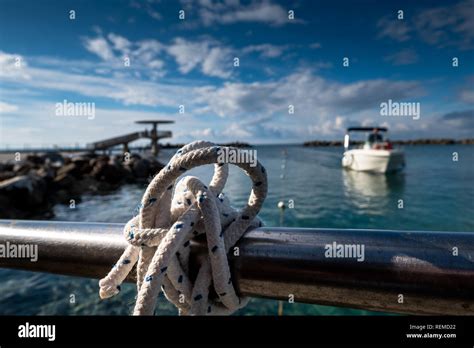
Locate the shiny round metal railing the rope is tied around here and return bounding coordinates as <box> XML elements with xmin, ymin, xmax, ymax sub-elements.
<box><xmin>0</xmin><ymin>220</ymin><xmax>474</xmax><ymax>315</ymax></box>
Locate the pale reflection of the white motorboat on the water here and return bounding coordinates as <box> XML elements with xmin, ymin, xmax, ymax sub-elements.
<box><xmin>342</xmin><ymin>169</ymin><xmax>405</xmax><ymax>215</ymax></box>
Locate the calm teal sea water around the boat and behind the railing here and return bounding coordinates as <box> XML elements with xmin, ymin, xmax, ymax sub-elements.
<box><xmin>0</xmin><ymin>145</ymin><xmax>474</xmax><ymax>315</ymax></box>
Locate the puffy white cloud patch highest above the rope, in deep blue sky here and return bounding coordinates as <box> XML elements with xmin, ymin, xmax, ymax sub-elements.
<box><xmin>83</xmin><ymin>29</ymin><xmax>289</xmax><ymax>80</ymax></box>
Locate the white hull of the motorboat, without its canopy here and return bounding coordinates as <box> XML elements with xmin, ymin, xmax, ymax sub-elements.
<box><xmin>342</xmin><ymin>149</ymin><xmax>405</xmax><ymax>173</ymax></box>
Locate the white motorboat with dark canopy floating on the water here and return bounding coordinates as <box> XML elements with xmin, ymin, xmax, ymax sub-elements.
<box><xmin>342</xmin><ymin>127</ymin><xmax>405</xmax><ymax>173</ymax></box>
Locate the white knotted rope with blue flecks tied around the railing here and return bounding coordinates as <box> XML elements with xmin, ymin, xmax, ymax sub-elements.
<box><xmin>99</xmin><ymin>141</ymin><xmax>267</xmax><ymax>315</ymax></box>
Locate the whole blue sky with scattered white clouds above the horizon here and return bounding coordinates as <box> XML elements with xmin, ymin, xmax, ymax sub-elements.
<box><xmin>0</xmin><ymin>0</ymin><xmax>474</xmax><ymax>148</ymax></box>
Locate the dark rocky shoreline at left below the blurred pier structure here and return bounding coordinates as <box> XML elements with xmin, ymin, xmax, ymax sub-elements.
<box><xmin>0</xmin><ymin>152</ymin><xmax>163</xmax><ymax>219</ymax></box>
